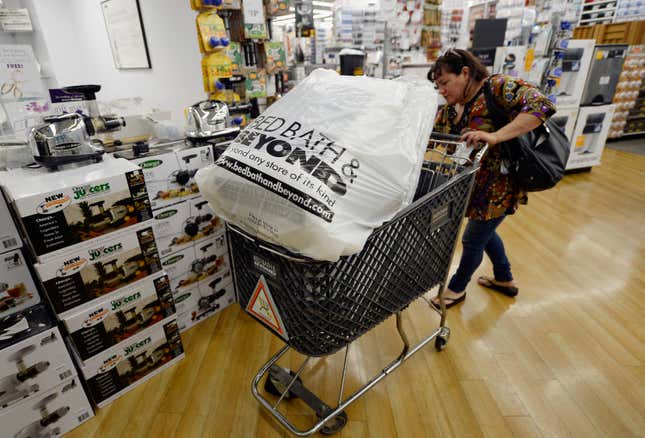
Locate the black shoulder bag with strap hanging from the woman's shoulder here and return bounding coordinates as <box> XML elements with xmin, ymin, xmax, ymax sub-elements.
<box><xmin>484</xmin><ymin>81</ymin><xmax>570</xmax><ymax>192</ymax></box>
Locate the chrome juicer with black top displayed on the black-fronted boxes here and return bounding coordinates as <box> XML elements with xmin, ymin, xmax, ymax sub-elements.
<box><xmin>29</xmin><ymin>85</ymin><xmax>125</xmax><ymax>170</ymax></box>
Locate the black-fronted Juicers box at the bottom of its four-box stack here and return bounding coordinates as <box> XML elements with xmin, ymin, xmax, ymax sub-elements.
<box><xmin>81</xmin><ymin>315</ymin><xmax>184</xmax><ymax>407</ymax></box>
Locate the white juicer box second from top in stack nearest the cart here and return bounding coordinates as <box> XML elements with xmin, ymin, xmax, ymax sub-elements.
<box><xmin>152</xmin><ymin>196</ymin><xmax>224</xmax><ymax>257</ymax></box>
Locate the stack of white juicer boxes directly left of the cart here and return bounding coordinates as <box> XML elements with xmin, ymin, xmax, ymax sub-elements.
<box><xmin>119</xmin><ymin>142</ymin><xmax>235</xmax><ymax>331</ymax></box>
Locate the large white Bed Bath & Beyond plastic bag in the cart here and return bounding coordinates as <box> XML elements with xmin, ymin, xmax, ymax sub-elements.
<box><xmin>196</xmin><ymin>69</ymin><xmax>437</xmax><ymax>261</ymax></box>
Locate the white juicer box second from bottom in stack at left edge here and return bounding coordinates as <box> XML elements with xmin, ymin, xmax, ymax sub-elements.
<box><xmin>0</xmin><ymin>327</ymin><xmax>76</xmax><ymax>415</ymax></box>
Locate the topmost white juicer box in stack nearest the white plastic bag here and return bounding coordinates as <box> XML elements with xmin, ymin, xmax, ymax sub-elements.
<box><xmin>118</xmin><ymin>145</ymin><xmax>214</xmax><ymax>210</ymax></box>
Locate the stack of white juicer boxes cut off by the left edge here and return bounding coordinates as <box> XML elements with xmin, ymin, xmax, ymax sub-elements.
<box><xmin>0</xmin><ymin>193</ymin><xmax>94</xmax><ymax>437</ymax></box>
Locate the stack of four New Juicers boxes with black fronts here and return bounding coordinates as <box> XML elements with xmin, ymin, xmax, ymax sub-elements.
<box><xmin>0</xmin><ymin>156</ymin><xmax>184</xmax><ymax>412</ymax></box>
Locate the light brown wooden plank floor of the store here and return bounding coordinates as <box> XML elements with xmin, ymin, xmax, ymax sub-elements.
<box><xmin>69</xmin><ymin>150</ymin><xmax>645</xmax><ymax>438</ymax></box>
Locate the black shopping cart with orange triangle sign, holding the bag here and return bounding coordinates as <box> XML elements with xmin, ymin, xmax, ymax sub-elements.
<box><xmin>227</xmin><ymin>134</ymin><xmax>485</xmax><ymax>436</ymax></box>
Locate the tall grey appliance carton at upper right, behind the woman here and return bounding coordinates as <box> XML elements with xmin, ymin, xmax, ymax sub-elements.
<box><xmin>580</xmin><ymin>44</ymin><xmax>628</xmax><ymax>106</ymax></box>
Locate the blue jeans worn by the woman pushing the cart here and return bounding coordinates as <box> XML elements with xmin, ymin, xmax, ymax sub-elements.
<box><xmin>448</xmin><ymin>216</ymin><xmax>513</xmax><ymax>292</ymax></box>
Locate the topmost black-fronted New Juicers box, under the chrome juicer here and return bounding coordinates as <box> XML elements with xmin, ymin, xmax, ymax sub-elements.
<box><xmin>0</xmin><ymin>158</ymin><xmax>152</xmax><ymax>261</ymax></box>
